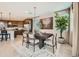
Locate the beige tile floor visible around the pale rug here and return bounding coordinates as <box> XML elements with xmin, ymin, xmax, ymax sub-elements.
<box><xmin>0</xmin><ymin>36</ymin><xmax>72</xmax><ymax>57</ymax></box>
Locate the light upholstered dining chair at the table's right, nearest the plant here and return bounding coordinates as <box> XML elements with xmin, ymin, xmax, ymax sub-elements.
<box><xmin>45</xmin><ymin>34</ymin><xmax>57</xmax><ymax>54</ymax></box>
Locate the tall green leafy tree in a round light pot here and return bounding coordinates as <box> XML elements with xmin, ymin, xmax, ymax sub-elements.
<box><xmin>55</xmin><ymin>13</ymin><xmax>68</xmax><ymax>43</ymax></box>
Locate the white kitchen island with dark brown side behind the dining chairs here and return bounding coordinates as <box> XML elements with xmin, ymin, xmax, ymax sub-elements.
<box><xmin>0</xmin><ymin>27</ymin><xmax>24</xmax><ymax>40</ymax></box>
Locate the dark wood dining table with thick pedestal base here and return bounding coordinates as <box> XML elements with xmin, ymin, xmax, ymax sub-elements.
<box><xmin>34</xmin><ymin>33</ymin><xmax>53</xmax><ymax>49</ymax></box>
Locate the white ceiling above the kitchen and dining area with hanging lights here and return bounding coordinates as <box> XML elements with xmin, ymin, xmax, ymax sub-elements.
<box><xmin>0</xmin><ymin>2</ymin><xmax>72</xmax><ymax>20</ymax></box>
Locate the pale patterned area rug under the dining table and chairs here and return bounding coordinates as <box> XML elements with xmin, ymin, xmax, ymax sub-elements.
<box><xmin>12</xmin><ymin>42</ymin><xmax>55</xmax><ymax>57</ymax></box>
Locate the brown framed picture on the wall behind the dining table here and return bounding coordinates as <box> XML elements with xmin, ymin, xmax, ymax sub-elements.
<box><xmin>40</xmin><ymin>17</ymin><xmax>53</xmax><ymax>29</ymax></box>
